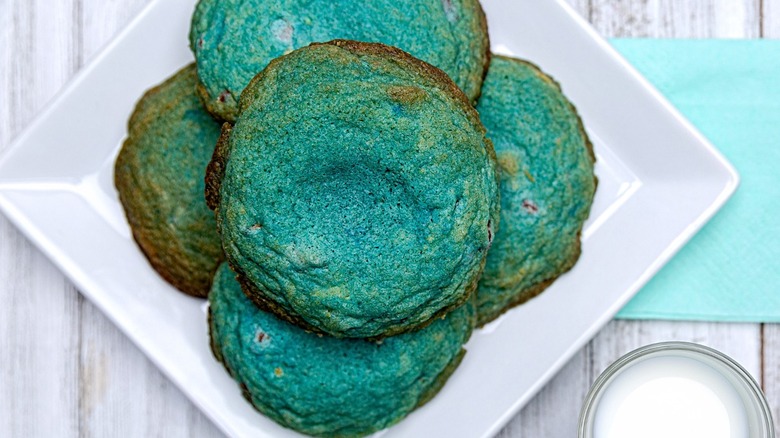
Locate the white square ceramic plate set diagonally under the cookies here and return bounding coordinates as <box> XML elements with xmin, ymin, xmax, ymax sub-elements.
<box><xmin>0</xmin><ymin>0</ymin><xmax>738</xmax><ymax>437</ymax></box>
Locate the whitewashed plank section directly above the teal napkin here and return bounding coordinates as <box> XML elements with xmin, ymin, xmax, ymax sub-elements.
<box><xmin>591</xmin><ymin>0</ymin><xmax>760</xmax><ymax>38</ymax></box>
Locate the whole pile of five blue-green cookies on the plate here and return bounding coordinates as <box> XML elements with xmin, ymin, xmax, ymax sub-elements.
<box><xmin>115</xmin><ymin>0</ymin><xmax>596</xmax><ymax>436</ymax></box>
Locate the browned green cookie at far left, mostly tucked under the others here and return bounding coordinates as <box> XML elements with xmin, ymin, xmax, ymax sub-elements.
<box><xmin>114</xmin><ymin>65</ymin><xmax>223</xmax><ymax>297</ymax></box>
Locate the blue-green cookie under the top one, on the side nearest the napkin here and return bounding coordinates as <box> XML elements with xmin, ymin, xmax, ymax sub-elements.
<box><xmin>477</xmin><ymin>56</ymin><xmax>596</xmax><ymax>325</ymax></box>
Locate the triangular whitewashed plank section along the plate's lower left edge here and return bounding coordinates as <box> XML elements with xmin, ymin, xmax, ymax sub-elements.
<box><xmin>79</xmin><ymin>300</ymin><xmax>222</xmax><ymax>438</ymax></box>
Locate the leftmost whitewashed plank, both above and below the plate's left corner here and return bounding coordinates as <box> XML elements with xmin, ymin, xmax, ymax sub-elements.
<box><xmin>0</xmin><ymin>0</ymin><xmax>79</xmax><ymax>437</ymax></box>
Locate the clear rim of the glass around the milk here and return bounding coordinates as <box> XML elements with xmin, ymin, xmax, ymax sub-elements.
<box><xmin>577</xmin><ymin>341</ymin><xmax>775</xmax><ymax>438</ymax></box>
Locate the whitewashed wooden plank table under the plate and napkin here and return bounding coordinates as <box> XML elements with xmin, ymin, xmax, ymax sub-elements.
<box><xmin>0</xmin><ymin>0</ymin><xmax>780</xmax><ymax>437</ymax></box>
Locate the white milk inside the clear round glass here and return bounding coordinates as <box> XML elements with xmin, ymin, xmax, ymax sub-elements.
<box><xmin>593</xmin><ymin>355</ymin><xmax>750</xmax><ymax>438</ymax></box>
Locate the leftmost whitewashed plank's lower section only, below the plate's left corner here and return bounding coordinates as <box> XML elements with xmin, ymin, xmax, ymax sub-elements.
<box><xmin>0</xmin><ymin>216</ymin><xmax>79</xmax><ymax>437</ymax></box>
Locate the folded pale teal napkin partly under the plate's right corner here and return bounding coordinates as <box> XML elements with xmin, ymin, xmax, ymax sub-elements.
<box><xmin>611</xmin><ymin>39</ymin><xmax>780</xmax><ymax>322</ymax></box>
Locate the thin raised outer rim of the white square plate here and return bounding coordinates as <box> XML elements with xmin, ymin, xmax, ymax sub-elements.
<box><xmin>0</xmin><ymin>0</ymin><xmax>740</xmax><ymax>437</ymax></box>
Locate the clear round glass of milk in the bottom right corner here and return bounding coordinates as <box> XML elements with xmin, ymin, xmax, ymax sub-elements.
<box><xmin>578</xmin><ymin>342</ymin><xmax>775</xmax><ymax>438</ymax></box>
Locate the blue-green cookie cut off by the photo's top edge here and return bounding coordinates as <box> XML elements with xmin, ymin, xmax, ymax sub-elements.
<box><xmin>190</xmin><ymin>0</ymin><xmax>490</xmax><ymax>122</ymax></box>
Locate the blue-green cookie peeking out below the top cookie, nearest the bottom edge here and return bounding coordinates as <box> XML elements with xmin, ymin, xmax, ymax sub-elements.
<box><xmin>209</xmin><ymin>264</ymin><xmax>476</xmax><ymax>437</ymax></box>
